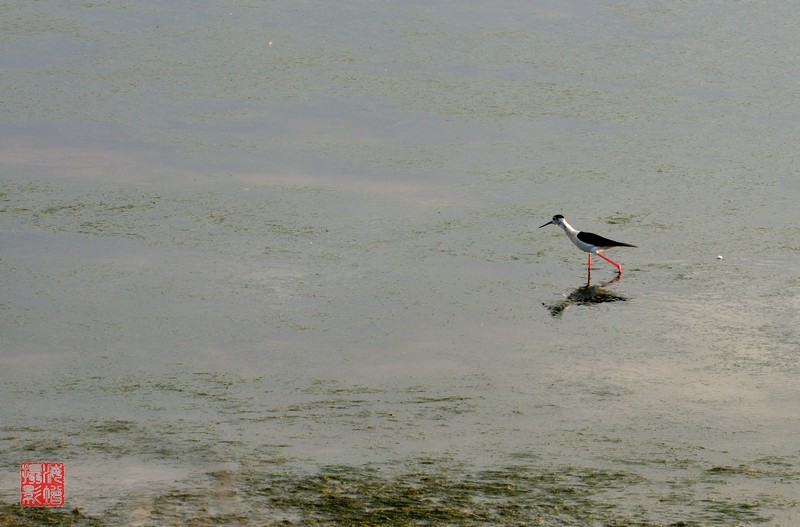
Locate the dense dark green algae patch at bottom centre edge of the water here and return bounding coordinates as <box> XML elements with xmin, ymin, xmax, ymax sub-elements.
<box><xmin>260</xmin><ymin>467</ymin><xmax>648</xmax><ymax>527</ymax></box>
